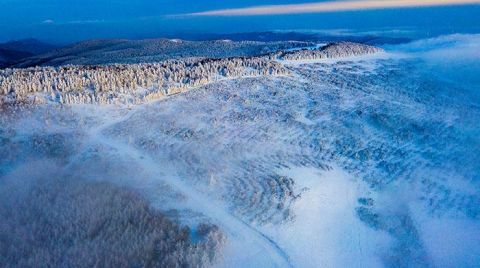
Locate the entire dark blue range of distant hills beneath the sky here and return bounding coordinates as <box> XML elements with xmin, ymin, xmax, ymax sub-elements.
<box><xmin>0</xmin><ymin>31</ymin><xmax>410</xmax><ymax>68</ymax></box>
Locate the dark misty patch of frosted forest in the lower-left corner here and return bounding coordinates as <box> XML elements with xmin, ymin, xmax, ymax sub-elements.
<box><xmin>0</xmin><ymin>175</ymin><xmax>224</xmax><ymax>267</ymax></box>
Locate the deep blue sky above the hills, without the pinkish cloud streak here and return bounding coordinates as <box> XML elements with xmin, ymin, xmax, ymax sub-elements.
<box><xmin>0</xmin><ymin>0</ymin><xmax>480</xmax><ymax>42</ymax></box>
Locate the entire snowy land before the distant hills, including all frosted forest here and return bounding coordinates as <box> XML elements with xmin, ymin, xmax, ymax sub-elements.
<box><xmin>0</xmin><ymin>35</ymin><xmax>480</xmax><ymax>267</ymax></box>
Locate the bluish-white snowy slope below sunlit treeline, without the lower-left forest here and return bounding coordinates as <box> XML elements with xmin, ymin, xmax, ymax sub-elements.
<box><xmin>0</xmin><ymin>35</ymin><xmax>480</xmax><ymax>267</ymax></box>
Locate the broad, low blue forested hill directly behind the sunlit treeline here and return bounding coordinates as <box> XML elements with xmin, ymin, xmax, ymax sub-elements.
<box><xmin>14</xmin><ymin>39</ymin><xmax>313</xmax><ymax>67</ymax></box>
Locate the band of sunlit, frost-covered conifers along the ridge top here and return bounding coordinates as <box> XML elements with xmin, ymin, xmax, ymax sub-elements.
<box><xmin>0</xmin><ymin>42</ymin><xmax>383</xmax><ymax>105</ymax></box>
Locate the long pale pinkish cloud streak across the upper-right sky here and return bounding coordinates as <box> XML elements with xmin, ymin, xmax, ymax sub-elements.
<box><xmin>187</xmin><ymin>0</ymin><xmax>480</xmax><ymax>16</ymax></box>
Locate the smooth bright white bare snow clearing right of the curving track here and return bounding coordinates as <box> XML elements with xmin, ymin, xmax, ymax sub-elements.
<box><xmin>264</xmin><ymin>167</ymin><xmax>391</xmax><ymax>267</ymax></box>
